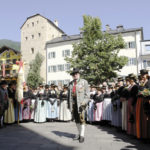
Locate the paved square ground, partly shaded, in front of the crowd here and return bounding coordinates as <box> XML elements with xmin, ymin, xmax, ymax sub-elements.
<box><xmin>0</xmin><ymin>122</ymin><xmax>150</xmax><ymax>150</ymax></box>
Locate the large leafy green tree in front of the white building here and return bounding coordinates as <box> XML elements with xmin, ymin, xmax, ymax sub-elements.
<box><xmin>66</xmin><ymin>16</ymin><xmax>127</xmax><ymax>84</ymax></box>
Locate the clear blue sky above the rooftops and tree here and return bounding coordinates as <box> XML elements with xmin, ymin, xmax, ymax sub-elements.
<box><xmin>0</xmin><ymin>0</ymin><xmax>150</xmax><ymax>41</ymax></box>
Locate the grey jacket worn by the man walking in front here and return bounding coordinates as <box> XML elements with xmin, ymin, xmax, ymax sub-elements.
<box><xmin>68</xmin><ymin>79</ymin><xmax>90</xmax><ymax>111</ymax></box>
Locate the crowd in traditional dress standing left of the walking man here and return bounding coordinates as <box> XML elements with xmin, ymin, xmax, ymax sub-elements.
<box><xmin>0</xmin><ymin>81</ymin><xmax>71</xmax><ymax>127</ymax></box>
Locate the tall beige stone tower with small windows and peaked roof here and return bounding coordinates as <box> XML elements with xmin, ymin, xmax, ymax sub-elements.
<box><xmin>21</xmin><ymin>14</ymin><xmax>64</xmax><ymax>82</ymax></box>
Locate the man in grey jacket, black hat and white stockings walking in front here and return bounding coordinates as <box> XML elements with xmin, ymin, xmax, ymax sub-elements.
<box><xmin>68</xmin><ymin>68</ymin><xmax>90</xmax><ymax>143</ymax></box>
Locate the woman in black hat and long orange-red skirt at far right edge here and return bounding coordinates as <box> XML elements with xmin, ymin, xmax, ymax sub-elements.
<box><xmin>136</xmin><ymin>69</ymin><xmax>150</xmax><ymax>140</ymax></box>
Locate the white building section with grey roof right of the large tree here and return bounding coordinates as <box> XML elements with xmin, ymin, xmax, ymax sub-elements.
<box><xmin>108</xmin><ymin>25</ymin><xmax>143</xmax><ymax>76</ymax></box>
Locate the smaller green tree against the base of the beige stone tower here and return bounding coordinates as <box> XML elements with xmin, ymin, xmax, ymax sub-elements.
<box><xmin>27</xmin><ymin>53</ymin><xmax>44</xmax><ymax>88</ymax></box>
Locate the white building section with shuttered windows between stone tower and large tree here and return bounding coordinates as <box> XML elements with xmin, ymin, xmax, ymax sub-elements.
<box><xmin>46</xmin><ymin>35</ymin><xmax>81</xmax><ymax>86</ymax></box>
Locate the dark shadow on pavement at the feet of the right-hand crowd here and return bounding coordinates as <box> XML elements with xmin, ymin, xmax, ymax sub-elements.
<box><xmin>96</xmin><ymin>125</ymin><xmax>150</xmax><ymax>150</ymax></box>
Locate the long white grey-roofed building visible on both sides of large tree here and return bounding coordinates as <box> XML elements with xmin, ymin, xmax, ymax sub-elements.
<box><xmin>46</xmin><ymin>25</ymin><xmax>143</xmax><ymax>85</ymax></box>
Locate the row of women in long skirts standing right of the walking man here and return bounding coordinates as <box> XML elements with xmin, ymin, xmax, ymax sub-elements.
<box><xmin>87</xmin><ymin>69</ymin><xmax>150</xmax><ymax>139</ymax></box>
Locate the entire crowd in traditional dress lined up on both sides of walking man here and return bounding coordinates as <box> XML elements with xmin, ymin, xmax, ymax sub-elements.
<box><xmin>0</xmin><ymin>70</ymin><xmax>150</xmax><ymax>139</ymax></box>
